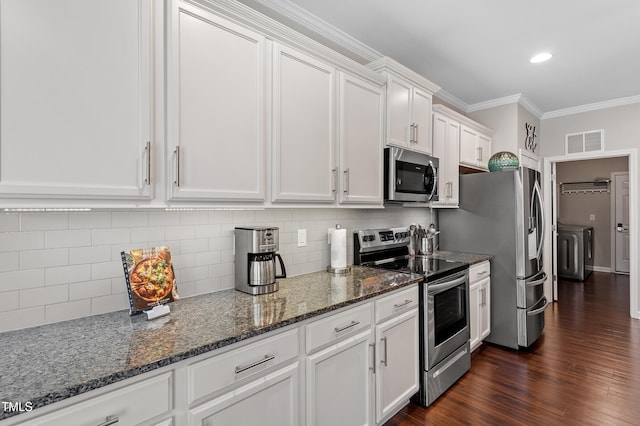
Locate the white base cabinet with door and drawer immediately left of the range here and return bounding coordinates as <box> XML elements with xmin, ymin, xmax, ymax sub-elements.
<box><xmin>375</xmin><ymin>286</ymin><xmax>420</xmax><ymax>424</ymax></box>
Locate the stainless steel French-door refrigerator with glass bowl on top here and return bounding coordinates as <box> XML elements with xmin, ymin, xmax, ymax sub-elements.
<box><xmin>439</xmin><ymin>167</ymin><xmax>548</xmax><ymax>349</ymax></box>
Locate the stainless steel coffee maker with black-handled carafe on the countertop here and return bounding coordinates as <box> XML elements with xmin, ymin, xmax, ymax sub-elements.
<box><xmin>235</xmin><ymin>226</ymin><xmax>287</xmax><ymax>295</ymax></box>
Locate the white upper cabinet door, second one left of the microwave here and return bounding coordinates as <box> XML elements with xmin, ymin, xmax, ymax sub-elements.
<box><xmin>272</xmin><ymin>43</ymin><xmax>337</xmax><ymax>202</ymax></box>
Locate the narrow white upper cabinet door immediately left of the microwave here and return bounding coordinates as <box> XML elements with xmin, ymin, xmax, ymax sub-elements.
<box><xmin>338</xmin><ymin>72</ymin><xmax>384</xmax><ymax>205</ymax></box>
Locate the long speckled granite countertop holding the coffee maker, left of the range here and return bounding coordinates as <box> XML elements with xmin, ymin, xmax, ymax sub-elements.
<box><xmin>0</xmin><ymin>266</ymin><xmax>422</xmax><ymax>420</ymax></box>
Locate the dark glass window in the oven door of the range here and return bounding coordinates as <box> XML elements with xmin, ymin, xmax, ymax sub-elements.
<box><xmin>433</xmin><ymin>285</ymin><xmax>467</xmax><ymax>347</ymax></box>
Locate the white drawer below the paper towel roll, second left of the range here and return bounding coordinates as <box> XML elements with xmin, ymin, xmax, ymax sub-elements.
<box><xmin>306</xmin><ymin>303</ymin><xmax>373</xmax><ymax>354</ymax></box>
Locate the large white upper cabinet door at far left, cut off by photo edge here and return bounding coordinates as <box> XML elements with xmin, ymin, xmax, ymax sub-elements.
<box><xmin>0</xmin><ymin>0</ymin><xmax>154</xmax><ymax>201</ymax></box>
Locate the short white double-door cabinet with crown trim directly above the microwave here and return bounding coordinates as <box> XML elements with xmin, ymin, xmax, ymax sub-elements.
<box><xmin>368</xmin><ymin>57</ymin><xmax>440</xmax><ymax>154</ymax></box>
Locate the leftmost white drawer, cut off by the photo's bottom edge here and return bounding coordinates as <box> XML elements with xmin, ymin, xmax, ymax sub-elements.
<box><xmin>21</xmin><ymin>373</ymin><xmax>173</xmax><ymax>426</ymax></box>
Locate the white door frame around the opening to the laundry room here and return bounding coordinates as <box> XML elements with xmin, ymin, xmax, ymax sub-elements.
<box><xmin>543</xmin><ymin>148</ymin><xmax>640</xmax><ymax>319</ymax></box>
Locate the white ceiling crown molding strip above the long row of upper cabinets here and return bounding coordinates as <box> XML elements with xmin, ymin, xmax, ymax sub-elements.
<box><xmin>248</xmin><ymin>0</ymin><xmax>383</xmax><ymax>62</ymax></box>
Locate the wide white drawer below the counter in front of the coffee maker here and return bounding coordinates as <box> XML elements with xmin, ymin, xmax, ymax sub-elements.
<box><xmin>187</xmin><ymin>329</ymin><xmax>299</xmax><ymax>404</ymax></box>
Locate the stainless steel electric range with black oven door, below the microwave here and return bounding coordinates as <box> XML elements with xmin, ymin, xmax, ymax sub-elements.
<box><xmin>354</xmin><ymin>227</ymin><xmax>471</xmax><ymax>406</ymax></box>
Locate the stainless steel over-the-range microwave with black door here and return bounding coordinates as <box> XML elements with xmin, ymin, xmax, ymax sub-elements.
<box><xmin>384</xmin><ymin>148</ymin><xmax>439</xmax><ymax>203</ymax></box>
